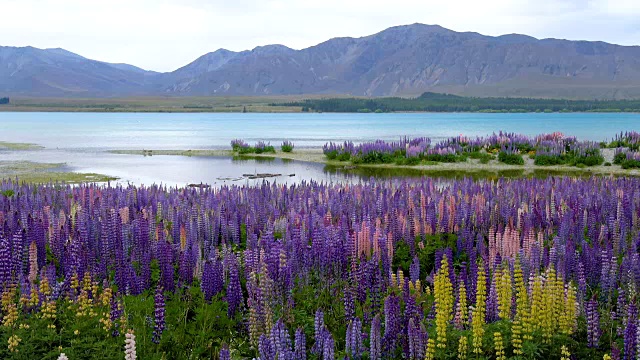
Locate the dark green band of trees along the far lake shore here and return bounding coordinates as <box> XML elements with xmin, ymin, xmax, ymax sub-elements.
<box><xmin>270</xmin><ymin>92</ymin><xmax>640</xmax><ymax>113</ymax></box>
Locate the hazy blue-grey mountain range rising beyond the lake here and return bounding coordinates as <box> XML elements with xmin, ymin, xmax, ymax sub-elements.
<box><xmin>0</xmin><ymin>24</ymin><xmax>640</xmax><ymax>99</ymax></box>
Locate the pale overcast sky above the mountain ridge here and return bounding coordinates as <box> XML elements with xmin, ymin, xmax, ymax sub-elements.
<box><xmin>0</xmin><ymin>0</ymin><xmax>640</xmax><ymax>71</ymax></box>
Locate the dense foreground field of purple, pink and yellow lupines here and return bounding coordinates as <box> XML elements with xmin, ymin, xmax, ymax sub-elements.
<box><xmin>0</xmin><ymin>177</ymin><xmax>640</xmax><ymax>360</ymax></box>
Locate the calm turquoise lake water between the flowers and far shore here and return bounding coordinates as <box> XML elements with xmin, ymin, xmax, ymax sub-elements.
<box><xmin>0</xmin><ymin>112</ymin><xmax>640</xmax><ymax>185</ymax></box>
